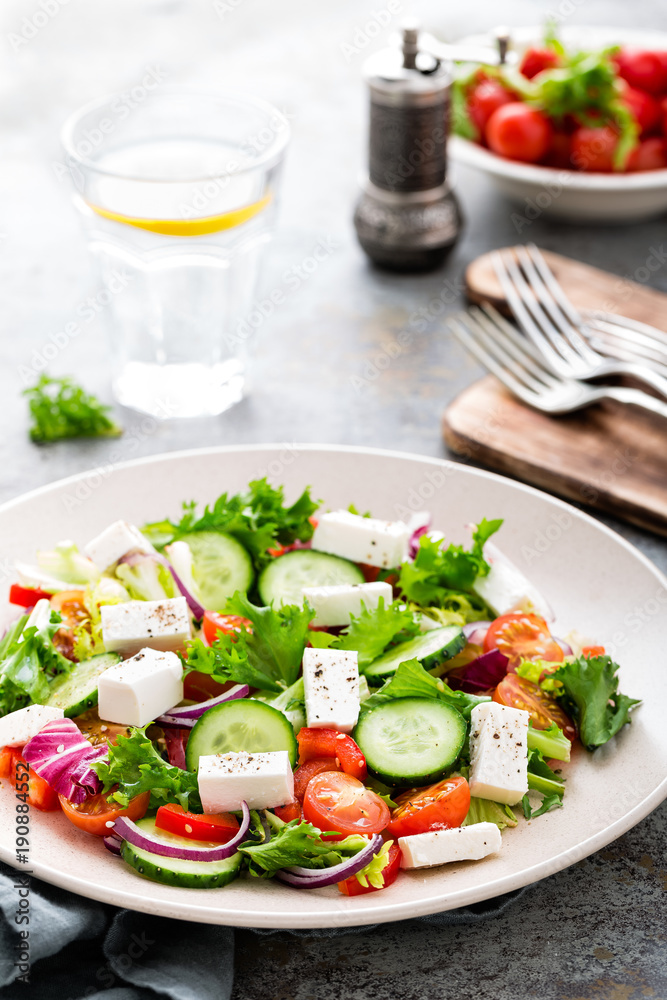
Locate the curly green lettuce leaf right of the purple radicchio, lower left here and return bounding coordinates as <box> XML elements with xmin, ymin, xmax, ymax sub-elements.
<box><xmin>93</xmin><ymin>729</ymin><xmax>202</xmax><ymax>812</ymax></box>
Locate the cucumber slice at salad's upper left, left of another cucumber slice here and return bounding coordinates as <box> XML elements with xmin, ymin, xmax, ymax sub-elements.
<box><xmin>179</xmin><ymin>531</ymin><xmax>255</xmax><ymax>611</ymax></box>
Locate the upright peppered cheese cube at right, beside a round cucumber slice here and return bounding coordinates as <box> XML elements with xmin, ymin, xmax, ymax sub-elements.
<box><xmin>468</xmin><ymin>701</ymin><xmax>530</xmax><ymax>806</ymax></box>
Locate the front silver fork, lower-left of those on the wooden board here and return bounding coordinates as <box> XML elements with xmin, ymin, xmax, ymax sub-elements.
<box><xmin>447</xmin><ymin>305</ymin><xmax>667</xmax><ymax>418</ymax></box>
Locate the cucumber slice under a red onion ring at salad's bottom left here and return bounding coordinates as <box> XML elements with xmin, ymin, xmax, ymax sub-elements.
<box><xmin>120</xmin><ymin>819</ymin><xmax>241</xmax><ymax>889</ymax></box>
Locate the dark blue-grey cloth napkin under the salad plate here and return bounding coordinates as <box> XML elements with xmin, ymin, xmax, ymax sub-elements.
<box><xmin>0</xmin><ymin>863</ymin><xmax>526</xmax><ymax>1000</ymax></box>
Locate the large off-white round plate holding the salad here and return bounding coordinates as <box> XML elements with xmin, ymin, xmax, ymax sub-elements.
<box><xmin>0</xmin><ymin>445</ymin><xmax>667</xmax><ymax>928</ymax></box>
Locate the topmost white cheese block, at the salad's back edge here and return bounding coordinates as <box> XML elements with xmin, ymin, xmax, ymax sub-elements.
<box><xmin>311</xmin><ymin>510</ymin><xmax>412</xmax><ymax>569</ymax></box>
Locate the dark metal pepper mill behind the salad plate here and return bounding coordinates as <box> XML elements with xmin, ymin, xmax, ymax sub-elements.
<box><xmin>354</xmin><ymin>26</ymin><xmax>462</xmax><ymax>271</ymax></box>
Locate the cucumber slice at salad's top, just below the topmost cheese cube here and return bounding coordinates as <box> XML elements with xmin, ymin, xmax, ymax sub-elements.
<box><xmin>257</xmin><ymin>549</ymin><xmax>364</xmax><ymax>607</ymax></box>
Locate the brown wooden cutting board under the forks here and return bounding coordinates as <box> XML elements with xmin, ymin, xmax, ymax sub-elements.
<box><xmin>443</xmin><ymin>247</ymin><xmax>667</xmax><ymax>535</ymax></box>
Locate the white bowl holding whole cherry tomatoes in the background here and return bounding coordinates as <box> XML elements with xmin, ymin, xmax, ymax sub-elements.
<box><xmin>449</xmin><ymin>25</ymin><xmax>667</xmax><ymax>222</ymax></box>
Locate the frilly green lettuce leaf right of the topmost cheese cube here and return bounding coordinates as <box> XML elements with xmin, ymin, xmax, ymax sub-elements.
<box><xmin>398</xmin><ymin>518</ymin><xmax>503</xmax><ymax>612</ymax></box>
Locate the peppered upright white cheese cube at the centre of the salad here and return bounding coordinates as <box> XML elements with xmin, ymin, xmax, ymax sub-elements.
<box><xmin>303</xmin><ymin>649</ymin><xmax>359</xmax><ymax>733</ymax></box>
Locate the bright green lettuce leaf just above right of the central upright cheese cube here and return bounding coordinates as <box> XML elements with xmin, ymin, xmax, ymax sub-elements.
<box><xmin>310</xmin><ymin>597</ymin><xmax>419</xmax><ymax>669</ymax></box>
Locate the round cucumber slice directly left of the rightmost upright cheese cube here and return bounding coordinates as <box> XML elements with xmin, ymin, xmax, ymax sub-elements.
<box><xmin>352</xmin><ymin>698</ymin><xmax>467</xmax><ymax>786</ymax></box>
